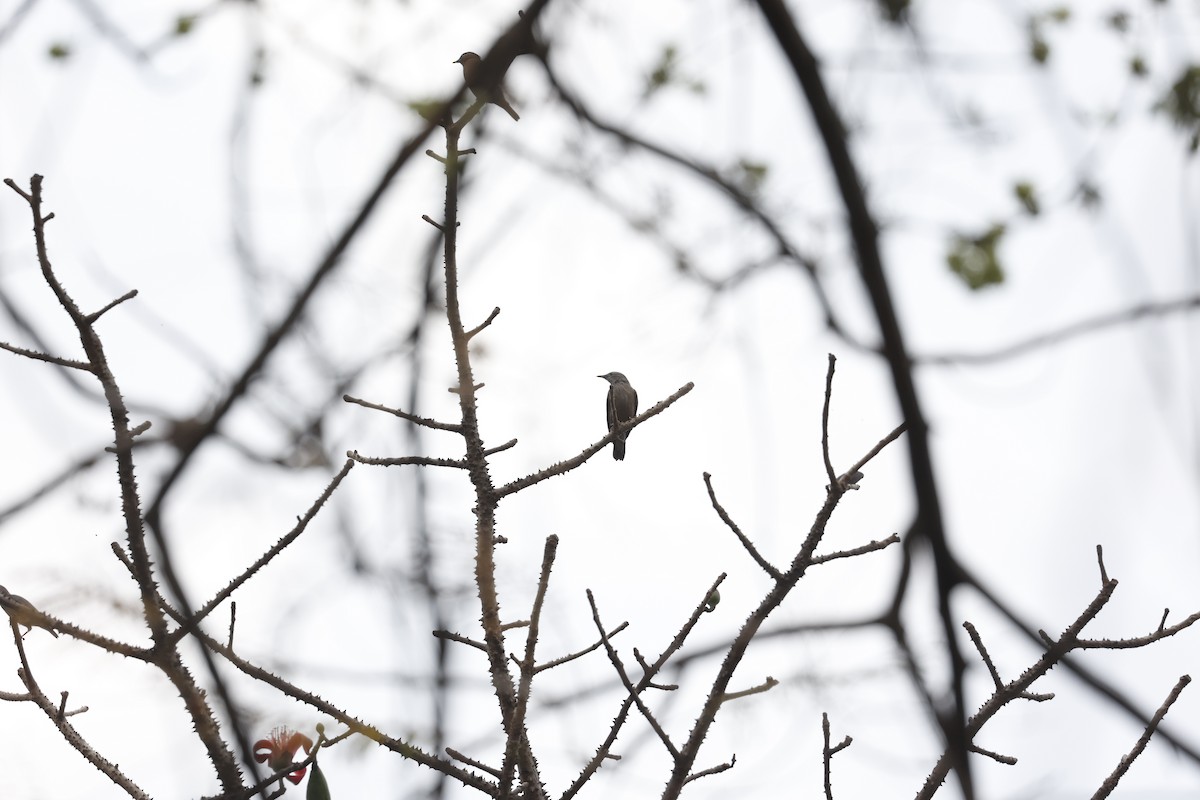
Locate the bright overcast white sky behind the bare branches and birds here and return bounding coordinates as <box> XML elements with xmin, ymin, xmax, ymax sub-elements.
<box><xmin>0</xmin><ymin>0</ymin><xmax>1200</xmax><ymax>800</ymax></box>
